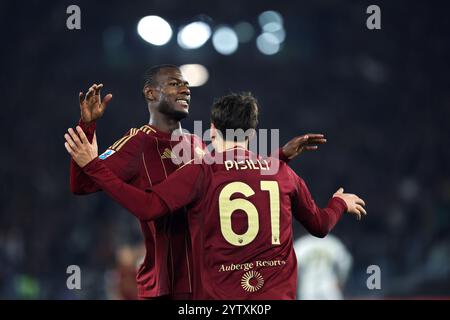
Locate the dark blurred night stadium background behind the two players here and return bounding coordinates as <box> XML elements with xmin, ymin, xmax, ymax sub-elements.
<box><xmin>0</xmin><ymin>0</ymin><xmax>450</xmax><ymax>299</ymax></box>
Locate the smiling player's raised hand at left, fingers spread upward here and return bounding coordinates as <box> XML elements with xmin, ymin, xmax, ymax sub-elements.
<box><xmin>79</xmin><ymin>83</ymin><xmax>112</xmax><ymax>124</ymax></box>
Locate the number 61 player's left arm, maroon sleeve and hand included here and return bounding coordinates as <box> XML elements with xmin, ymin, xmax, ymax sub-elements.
<box><xmin>65</xmin><ymin>127</ymin><xmax>204</xmax><ymax>220</ymax></box>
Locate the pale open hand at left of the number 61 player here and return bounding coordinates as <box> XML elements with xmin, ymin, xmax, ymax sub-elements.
<box><xmin>64</xmin><ymin>126</ymin><xmax>98</xmax><ymax>168</ymax></box>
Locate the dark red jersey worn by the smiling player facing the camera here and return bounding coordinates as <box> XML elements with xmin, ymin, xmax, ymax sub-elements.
<box><xmin>70</xmin><ymin>121</ymin><xmax>203</xmax><ymax>298</ymax></box>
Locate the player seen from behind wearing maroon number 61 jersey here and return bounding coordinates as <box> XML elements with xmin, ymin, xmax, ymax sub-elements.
<box><xmin>66</xmin><ymin>94</ymin><xmax>366</xmax><ymax>299</ymax></box>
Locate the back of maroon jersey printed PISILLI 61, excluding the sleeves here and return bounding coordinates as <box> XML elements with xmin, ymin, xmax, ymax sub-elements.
<box><xmin>189</xmin><ymin>150</ymin><xmax>297</xmax><ymax>300</ymax></box>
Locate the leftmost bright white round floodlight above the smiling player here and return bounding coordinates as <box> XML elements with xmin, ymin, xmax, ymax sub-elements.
<box><xmin>137</xmin><ymin>16</ymin><xmax>172</xmax><ymax>46</ymax></box>
